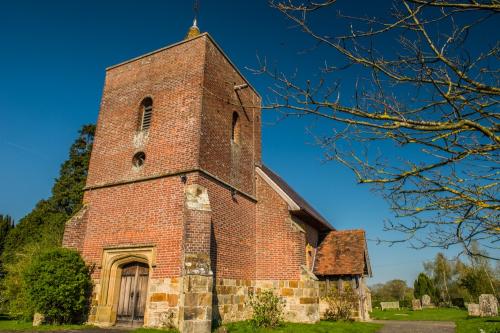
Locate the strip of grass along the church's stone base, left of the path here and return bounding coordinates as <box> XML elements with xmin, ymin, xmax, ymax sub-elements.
<box><xmin>225</xmin><ymin>321</ymin><xmax>382</xmax><ymax>333</ymax></box>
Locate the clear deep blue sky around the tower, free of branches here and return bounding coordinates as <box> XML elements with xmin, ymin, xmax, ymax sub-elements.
<box><xmin>0</xmin><ymin>0</ymin><xmax>470</xmax><ymax>284</ymax></box>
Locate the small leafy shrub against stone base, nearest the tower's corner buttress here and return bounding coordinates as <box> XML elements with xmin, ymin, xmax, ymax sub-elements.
<box><xmin>247</xmin><ymin>290</ymin><xmax>285</xmax><ymax>328</ymax></box>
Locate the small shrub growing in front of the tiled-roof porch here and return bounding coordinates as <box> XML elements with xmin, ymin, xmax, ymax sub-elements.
<box><xmin>323</xmin><ymin>284</ymin><xmax>359</xmax><ymax>321</ymax></box>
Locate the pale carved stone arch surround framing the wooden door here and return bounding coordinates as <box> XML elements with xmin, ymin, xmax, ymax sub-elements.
<box><xmin>95</xmin><ymin>246</ymin><xmax>156</xmax><ymax>327</ymax></box>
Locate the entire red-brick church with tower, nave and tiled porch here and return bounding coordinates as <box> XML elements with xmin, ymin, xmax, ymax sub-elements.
<box><xmin>63</xmin><ymin>23</ymin><xmax>371</xmax><ymax>333</ymax></box>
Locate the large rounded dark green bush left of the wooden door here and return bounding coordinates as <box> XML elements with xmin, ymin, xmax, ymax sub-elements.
<box><xmin>24</xmin><ymin>248</ymin><xmax>92</xmax><ymax>324</ymax></box>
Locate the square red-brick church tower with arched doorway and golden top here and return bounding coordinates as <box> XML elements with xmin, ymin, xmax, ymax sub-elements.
<box><xmin>63</xmin><ymin>22</ymin><xmax>261</xmax><ymax>332</ymax></box>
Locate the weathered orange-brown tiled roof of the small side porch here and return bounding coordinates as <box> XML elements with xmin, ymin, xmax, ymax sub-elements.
<box><xmin>314</xmin><ymin>230</ymin><xmax>371</xmax><ymax>276</ymax></box>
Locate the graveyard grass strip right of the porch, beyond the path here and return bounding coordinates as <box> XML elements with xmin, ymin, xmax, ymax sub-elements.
<box><xmin>370</xmin><ymin>308</ymin><xmax>467</xmax><ymax>321</ymax></box>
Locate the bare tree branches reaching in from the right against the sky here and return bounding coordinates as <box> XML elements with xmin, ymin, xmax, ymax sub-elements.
<box><xmin>255</xmin><ymin>0</ymin><xmax>500</xmax><ymax>259</ymax></box>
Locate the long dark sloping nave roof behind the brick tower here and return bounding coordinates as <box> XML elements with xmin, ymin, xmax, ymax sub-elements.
<box><xmin>262</xmin><ymin>165</ymin><xmax>335</xmax><ymax>230</ymax></box>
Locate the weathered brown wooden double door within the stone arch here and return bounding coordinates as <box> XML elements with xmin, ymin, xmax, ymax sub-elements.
<box><xmin>117</xmin><ymin>262</ymin><xmax>149</xmax><ymax>324</ymax></box>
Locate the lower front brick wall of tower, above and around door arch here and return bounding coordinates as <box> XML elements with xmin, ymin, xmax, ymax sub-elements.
<box><xmin>82</xmin><ymin>177</ymin><xmax>185</xmax><ymax>278</ymax></box>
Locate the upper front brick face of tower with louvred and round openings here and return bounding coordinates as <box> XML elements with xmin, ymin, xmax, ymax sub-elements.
<box><xmin>87</xmin><ymin>38</ymin><xmax>205</xmax><ymax>186</ymax></box>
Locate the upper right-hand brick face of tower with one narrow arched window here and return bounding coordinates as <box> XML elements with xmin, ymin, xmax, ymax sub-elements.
<box><xmin>200</xmin><ymin>39</ymin><xmax>261</xmax><ymax>195</ymax></box>
